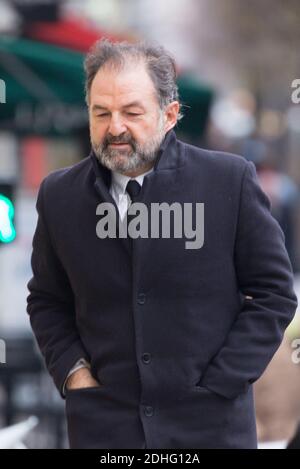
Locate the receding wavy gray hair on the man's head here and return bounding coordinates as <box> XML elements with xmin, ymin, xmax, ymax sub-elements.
<box><xmin>84</xmin><ymin>39</ymin><xmax>183</xmax><ymax>120</ymax></box>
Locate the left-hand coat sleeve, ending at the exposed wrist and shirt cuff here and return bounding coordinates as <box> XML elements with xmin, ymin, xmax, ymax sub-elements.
<box><xmin>27</xmin><ymin>179</ymin><xmax>89</xmax><ymax>397</ymax></box>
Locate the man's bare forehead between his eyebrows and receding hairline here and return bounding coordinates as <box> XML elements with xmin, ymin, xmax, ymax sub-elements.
<box><xmin>90</xmin><ymin>63</ymin><xmax>156</xmax><ymax>106</ymax></box>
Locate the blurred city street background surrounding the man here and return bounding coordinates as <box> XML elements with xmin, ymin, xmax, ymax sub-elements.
<box><xmin>0</xmin><ymin>0</ymin><xmax>300</xmax><ymax>448</ymax></box>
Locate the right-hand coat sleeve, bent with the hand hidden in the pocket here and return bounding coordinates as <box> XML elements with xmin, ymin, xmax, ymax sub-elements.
<box><xmin>201</xmin><ymin>163</ymin><xmax>297</xmax><ymax>398</ymax></box>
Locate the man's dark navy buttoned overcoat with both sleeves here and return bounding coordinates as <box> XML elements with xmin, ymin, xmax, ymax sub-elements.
<box><xmin>27</xmin><ymin>130</ymin><xmax>297</xmax><ymax>449</ymax></box>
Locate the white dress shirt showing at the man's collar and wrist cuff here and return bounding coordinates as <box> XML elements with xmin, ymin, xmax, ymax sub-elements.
<box><xmin>63</xmin><ymin>164</ymin><xmax>153</xmax><ymax>394</ymax></box>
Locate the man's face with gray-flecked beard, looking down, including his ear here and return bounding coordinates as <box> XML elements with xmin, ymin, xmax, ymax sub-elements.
<box><xmin>89</xmin><ymin>62</ymin><xmax>178</xmax><ymax>176</ymax></box>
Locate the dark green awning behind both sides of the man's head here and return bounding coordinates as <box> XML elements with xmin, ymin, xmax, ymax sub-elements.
<box><xmin>0</xmin><ymin>37</ymin><xmax>213</xmax><ymax>140</ymax></box>
